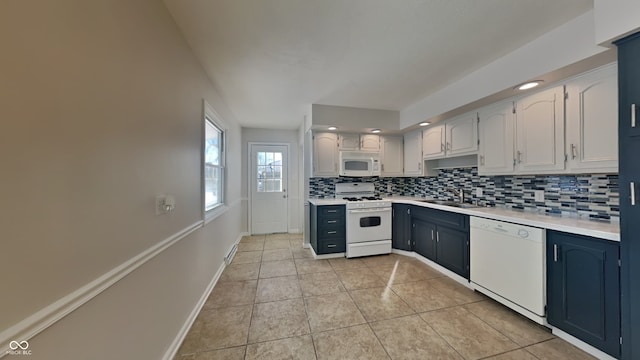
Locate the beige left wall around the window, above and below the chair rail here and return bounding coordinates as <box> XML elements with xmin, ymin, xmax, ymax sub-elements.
<box><xmin>0</xmin><ymin>0</ymin><xmax>246</xmax><ymax>359</ymax></box>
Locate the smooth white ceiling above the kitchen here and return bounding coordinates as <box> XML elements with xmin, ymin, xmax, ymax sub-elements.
<box><xmin>165</xmin><ymin>0</ymin><xmax>593</xmax><ymax>129</ymax></box>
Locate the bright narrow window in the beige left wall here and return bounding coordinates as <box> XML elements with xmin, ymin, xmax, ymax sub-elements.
<box><xmin>203</xmin><ymin>103</ymin><xmax>225</xmax><ymax>212</ymax></box>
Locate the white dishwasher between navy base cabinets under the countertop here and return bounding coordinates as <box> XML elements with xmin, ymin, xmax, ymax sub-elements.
<box><xmin>470</xmin><ymin>216</ymin><xmax>546</xmax><ymax>324</ymax></box>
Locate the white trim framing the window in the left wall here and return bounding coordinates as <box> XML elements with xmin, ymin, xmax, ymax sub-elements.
<box><xmin>200</xmin><ymin>99</ymin><xmax>229</xmax><ymax>225</ymax></box>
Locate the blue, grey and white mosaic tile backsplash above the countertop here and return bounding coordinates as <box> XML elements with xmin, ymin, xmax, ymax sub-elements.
<box><xmin>309</xmin><ymin>167</ymin><xmax>620</xmax><ymax>221</ymax></box>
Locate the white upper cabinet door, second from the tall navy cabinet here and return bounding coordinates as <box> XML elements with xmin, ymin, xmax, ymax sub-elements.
<box><xmin>516</xmin><ymin>87</ymin><xmax>564</xmax><ymax>173</ymax></box>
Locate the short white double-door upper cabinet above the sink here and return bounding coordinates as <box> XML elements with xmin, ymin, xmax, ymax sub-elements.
<box><xmin>422</xmin><ymin>113</ymin><xmax>478</xmax><ymax>160</ymax></box>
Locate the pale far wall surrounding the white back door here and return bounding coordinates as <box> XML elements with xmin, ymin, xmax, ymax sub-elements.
<box><xmin>241</xmin><ymin>128</ymin><xmax>303</xmax><ymax>232</ymax></box>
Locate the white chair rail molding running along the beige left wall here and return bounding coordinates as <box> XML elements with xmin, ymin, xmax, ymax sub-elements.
<box><xmin>0</xmin><ymin>220</ymin><xmax>203</xmax><ymax>358</ymax></box>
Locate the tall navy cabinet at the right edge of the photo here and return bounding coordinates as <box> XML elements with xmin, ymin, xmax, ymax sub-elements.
<box><xmin>616</xmin><ymin>33</ymin><xmax>640</xmax><ymax>359</ymax></box>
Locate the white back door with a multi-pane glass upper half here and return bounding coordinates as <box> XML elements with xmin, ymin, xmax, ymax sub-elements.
<box><xmin>250</xmin><ymin>144</ymin><xmax>289</xmax><ymax>234</ymax></box>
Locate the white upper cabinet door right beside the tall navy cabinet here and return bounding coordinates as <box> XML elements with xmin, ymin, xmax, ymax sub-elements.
<box><xmin>566</xmin><ymin>64</ymin><xmax>618</xmax><ymax>173</ymax></box>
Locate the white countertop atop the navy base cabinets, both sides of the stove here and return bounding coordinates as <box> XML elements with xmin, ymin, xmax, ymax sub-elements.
<box><xmin>309</xmin><ymin>196</ymin><xmax>620</xmax><ymax>241</ymax></box>
